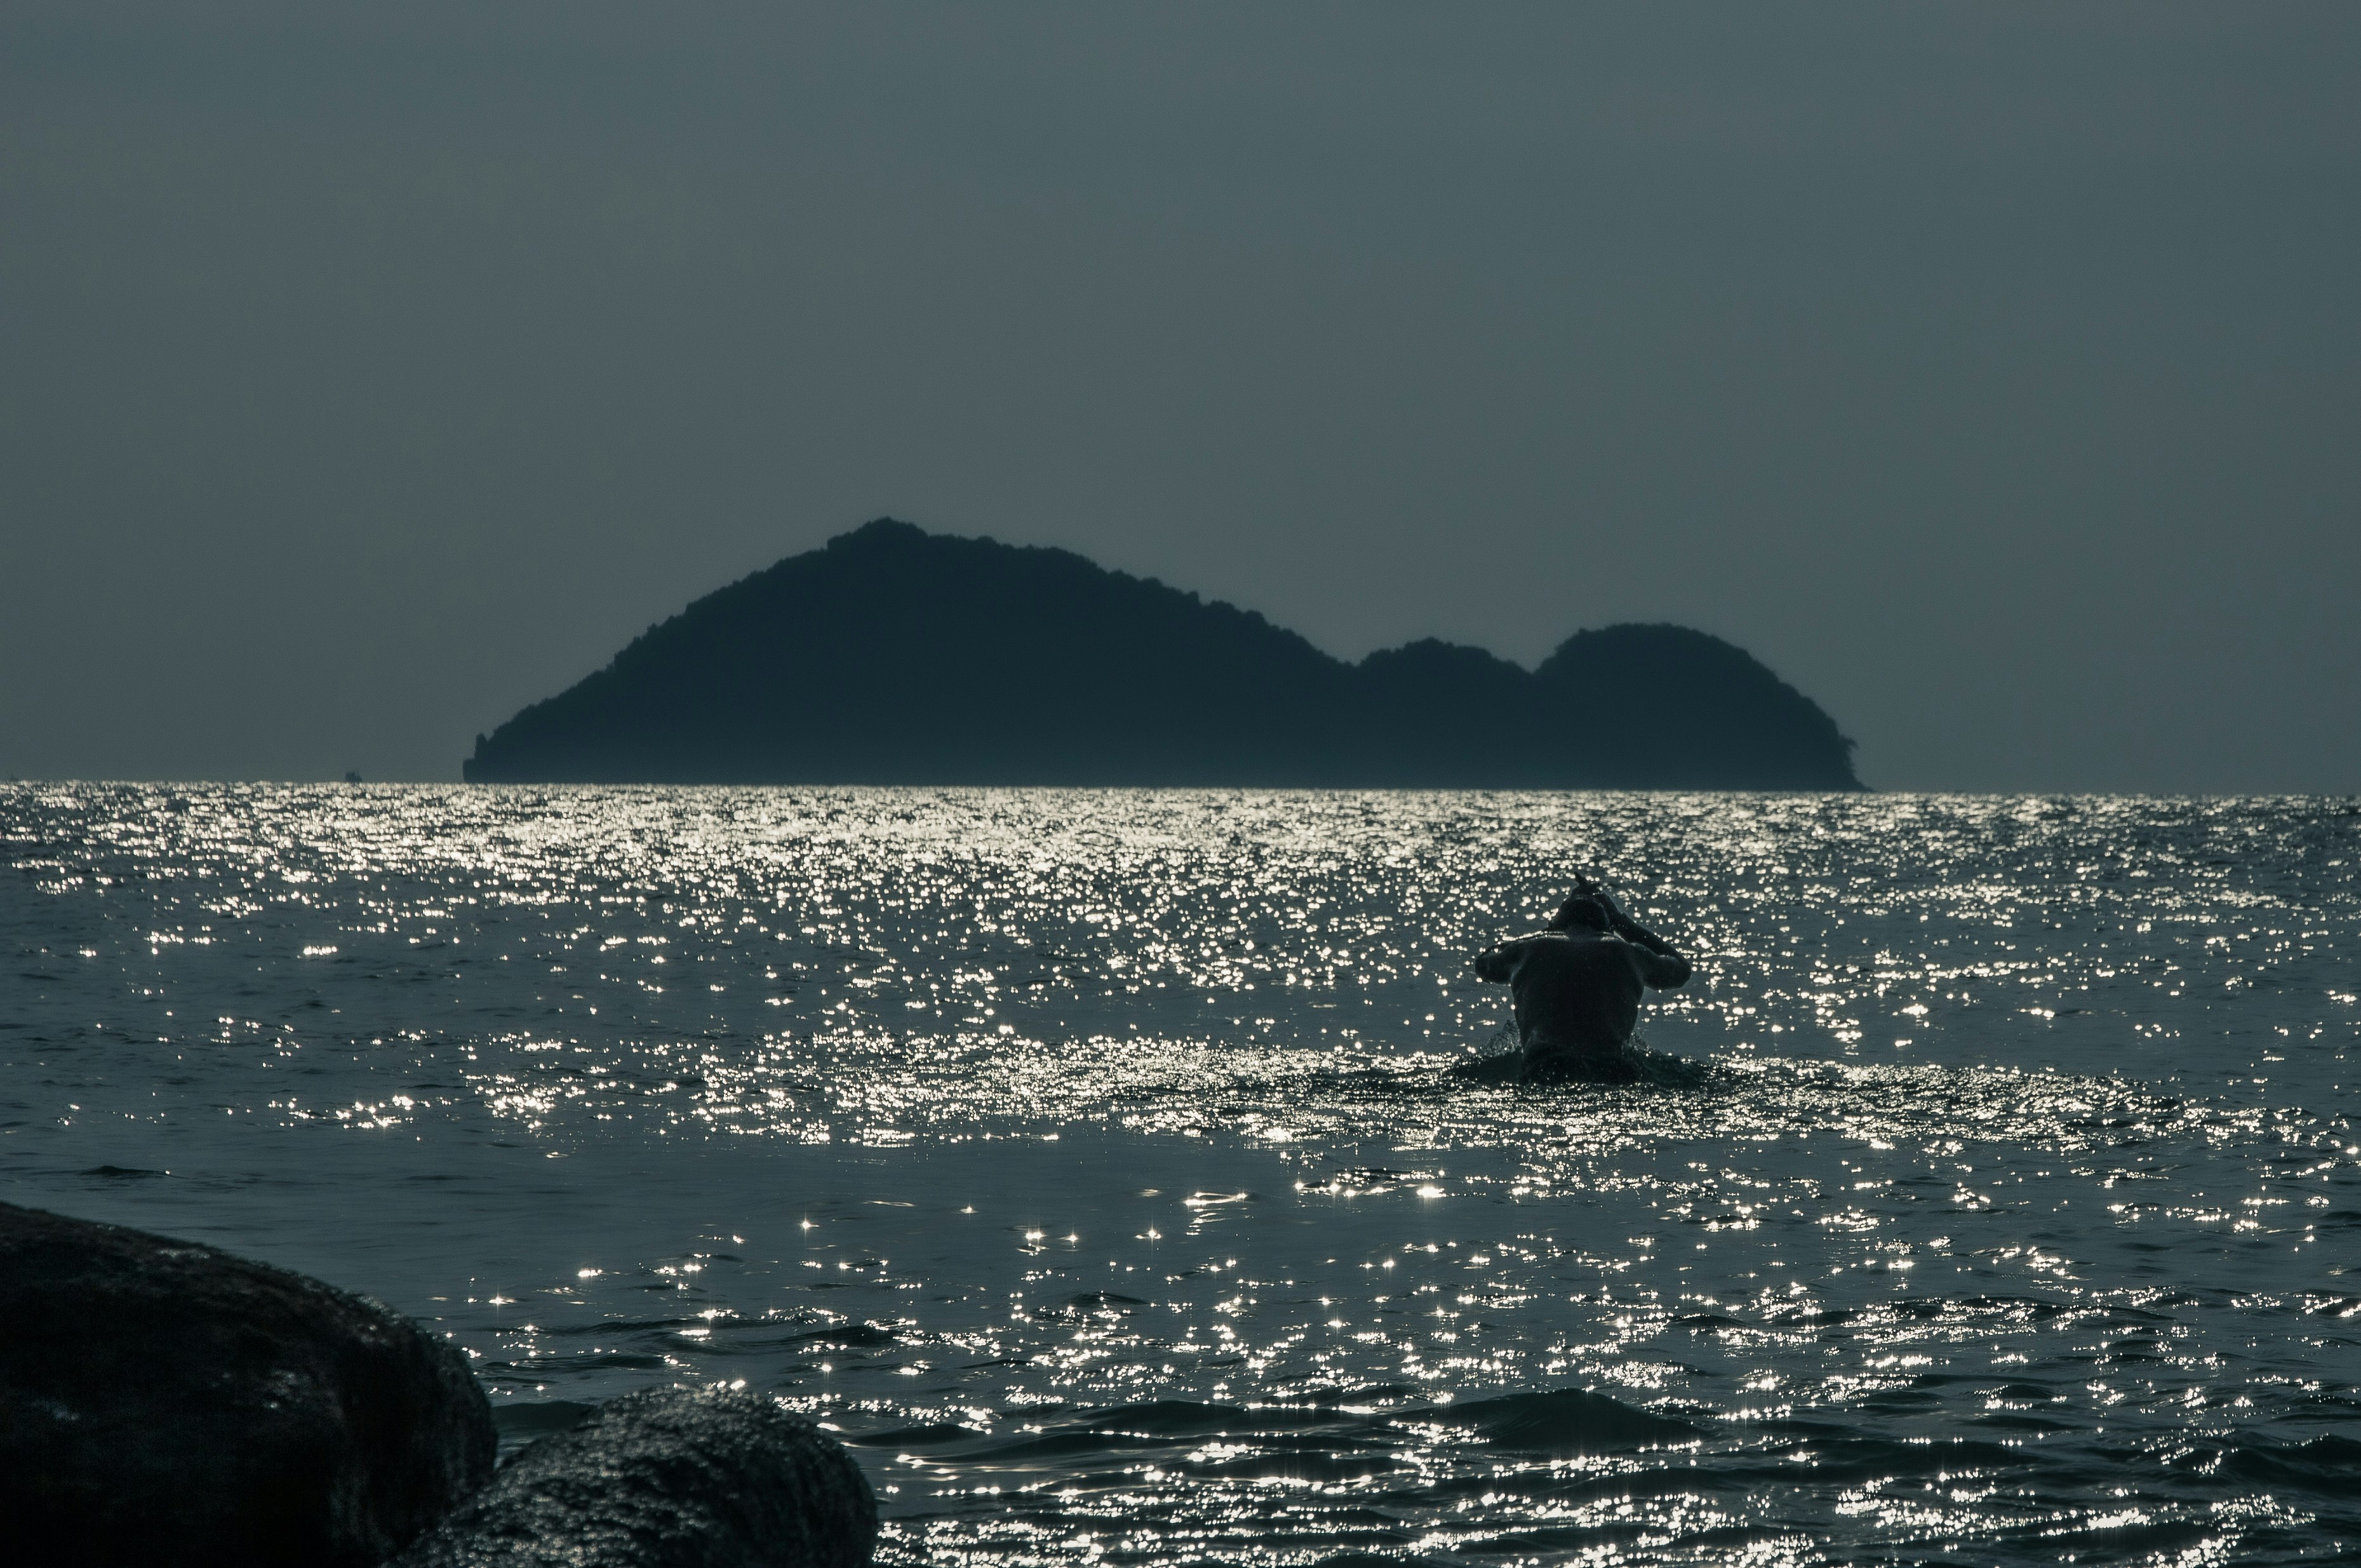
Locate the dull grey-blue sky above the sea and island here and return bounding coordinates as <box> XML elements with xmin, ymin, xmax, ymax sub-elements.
<box><xmin>0</xmin><ymin>0</ymin><xmax>2361</xmax><ymax>791</ymax></box>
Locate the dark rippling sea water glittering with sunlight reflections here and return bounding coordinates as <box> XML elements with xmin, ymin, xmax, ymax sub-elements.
<box><xmin>0</xmin><ymin>784</ymin><xmax>2361</xmax><ymax>1564</ymax></box>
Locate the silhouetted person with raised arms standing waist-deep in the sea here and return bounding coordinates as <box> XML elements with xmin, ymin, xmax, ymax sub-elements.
<box><xmin>1476</xmin><ymin>878</ymin><xmax>1690</xmax><ymax>1084</ymax></box>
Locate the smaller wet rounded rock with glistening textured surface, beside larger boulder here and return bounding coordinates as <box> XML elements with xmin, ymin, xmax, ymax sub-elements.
<box><xmin>394</xmin><ymin>1388</ymin><xmax>878</xmax><ymax>1568</ymax></box>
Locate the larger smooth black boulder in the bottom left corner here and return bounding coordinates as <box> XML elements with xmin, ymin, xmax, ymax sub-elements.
<box><xmin>0</xmin><ymin>1204</ymin><xmax>498</xmax><ymax>1568</ymax></box>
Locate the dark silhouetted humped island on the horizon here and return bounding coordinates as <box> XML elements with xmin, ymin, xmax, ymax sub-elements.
<box><xmin>465</xmin><ymin>519</ymin><xmax>1861</xmax><ymax>789</ymax></box>
